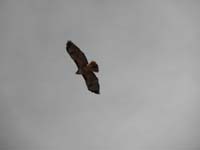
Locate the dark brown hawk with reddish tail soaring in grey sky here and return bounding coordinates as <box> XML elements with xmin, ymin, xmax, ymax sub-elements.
<box><xmin>66</xmin><ymin>41</ymin><xmax>100</xmax><ymax>94</ymax></box>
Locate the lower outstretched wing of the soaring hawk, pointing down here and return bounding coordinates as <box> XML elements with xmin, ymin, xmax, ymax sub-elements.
<box><xmin>82</xmin><ymin>71</ymin><xmax>100</xmax><ymax>94</ymax></box>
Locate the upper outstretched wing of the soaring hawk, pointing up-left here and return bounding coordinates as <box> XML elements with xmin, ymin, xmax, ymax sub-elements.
<box><xmin>66</xmin><ymin>41</ymin><xmax>88</xmax><ymax>68</ymax></box>
